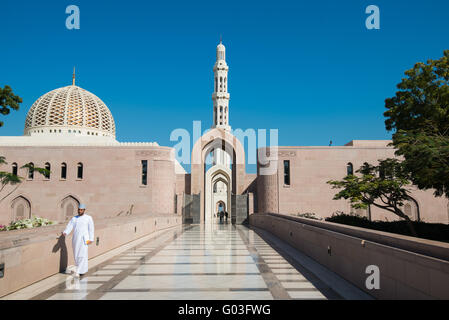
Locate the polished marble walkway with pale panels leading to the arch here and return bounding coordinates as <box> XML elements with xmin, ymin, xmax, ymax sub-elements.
<box><xmin>28</xmin><ymin>224</ymin><xmax>340</xmax><ymax>300</ymax></box>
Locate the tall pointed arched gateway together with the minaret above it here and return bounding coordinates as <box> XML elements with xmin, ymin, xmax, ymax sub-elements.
<box><xmin>186</xmin><ymin>42</ymin><xmax>247</xmax><ymax>223</ymax></box>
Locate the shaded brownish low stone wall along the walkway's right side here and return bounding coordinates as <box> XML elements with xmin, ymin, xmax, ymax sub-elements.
<box><xmin>249</xmin><ymin>214</ymin><xmax>449</xmax><ymax>299</ymax></box>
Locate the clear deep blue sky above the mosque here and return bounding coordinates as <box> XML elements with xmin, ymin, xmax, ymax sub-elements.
<box><xmin>0</xmin><ymin>0</ymin><xmax>449</xmax><ymax>172</ymax></box>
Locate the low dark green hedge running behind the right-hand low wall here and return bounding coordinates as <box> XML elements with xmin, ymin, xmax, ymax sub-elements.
<box><xmin>325</xmin><ymin>212</ymin><xmax>449</xmax><ymax>242</ymax></box>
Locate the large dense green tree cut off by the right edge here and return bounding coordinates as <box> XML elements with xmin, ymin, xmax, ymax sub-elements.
<box><xmin>384</xmin><ymin>50</ymin><xmax>449</xmax><ymax>197</ymax></box>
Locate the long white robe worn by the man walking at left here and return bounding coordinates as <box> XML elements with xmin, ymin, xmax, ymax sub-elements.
<box><xmin>64</xmin><ymin>214</ymin><xmax>94</xmax><ymax>274</ymax></box>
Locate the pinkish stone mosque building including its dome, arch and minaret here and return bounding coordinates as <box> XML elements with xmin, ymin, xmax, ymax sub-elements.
<box><xmin>0</xmin><ymin>42</ymin><xmax>449</xmax><ymax>224</ymax></box>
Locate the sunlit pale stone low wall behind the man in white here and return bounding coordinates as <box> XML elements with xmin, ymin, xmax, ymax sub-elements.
<box><xmin>0</xmin><ymin>215</ymin><xmax>182</xmax><ymax>297</ymax></box>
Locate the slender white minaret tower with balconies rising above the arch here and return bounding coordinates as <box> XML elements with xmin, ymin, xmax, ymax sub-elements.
<box><xmin>212</xmin><ymin>40</ymin><xmax>231</xmax><ymax>131</ymax></box>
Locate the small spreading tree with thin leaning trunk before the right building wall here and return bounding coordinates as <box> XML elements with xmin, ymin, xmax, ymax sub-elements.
<box><xmin>327</xmin><ymin>159</ymin><xmax>416</xmax><ymax>236</ymax></box>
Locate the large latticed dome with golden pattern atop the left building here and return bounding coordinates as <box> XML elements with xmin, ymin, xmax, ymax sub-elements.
<box><xmin>24</xmin><ymin>81</ymin><xmax>115</xmax><ymax>139</ymax></box>
